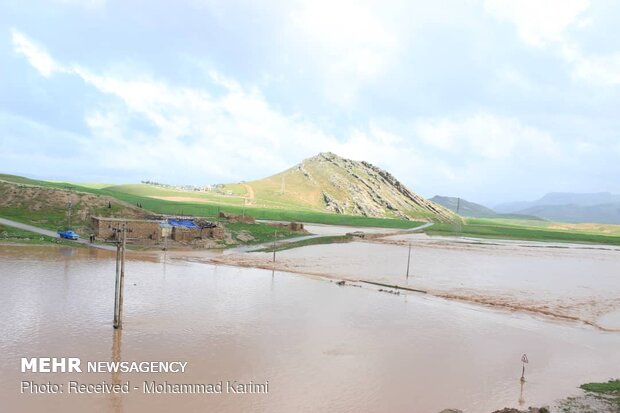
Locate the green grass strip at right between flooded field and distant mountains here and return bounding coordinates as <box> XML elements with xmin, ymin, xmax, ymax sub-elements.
<box><xmin>426</xmin><ymin>218</ymin><xmax>620</xmax><ymax>245</ymax></box>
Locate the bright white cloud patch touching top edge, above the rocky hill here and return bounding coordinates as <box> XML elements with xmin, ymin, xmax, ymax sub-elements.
<box><xmin>290</xmin><ymin>0</ymin><xmax>399</xmax><ymax>106</ymax></box>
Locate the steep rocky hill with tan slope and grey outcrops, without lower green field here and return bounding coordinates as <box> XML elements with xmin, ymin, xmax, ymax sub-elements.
<box><xmin>228</xmin><ymin>152</ymin><xmax>458</xmax><ymax>221</ymax></box>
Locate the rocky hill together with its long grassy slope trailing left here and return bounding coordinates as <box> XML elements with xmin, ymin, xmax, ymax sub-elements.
<box><xmin>75</xmin><ymin>153</ymin><xmax>460</xmax><ymax>227</ymax></box>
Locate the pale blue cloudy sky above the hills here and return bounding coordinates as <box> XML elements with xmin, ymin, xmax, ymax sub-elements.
<box><xmin>0</xmin><ymin>0</ymin><xmax>620</xmax><ymax>205</ymax></box>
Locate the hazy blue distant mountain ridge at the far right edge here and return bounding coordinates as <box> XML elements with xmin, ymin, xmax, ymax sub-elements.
<box><xmin>495</xmin><ymin>192</ymin><xmax>620</xmax><ymax>224</ymax></box>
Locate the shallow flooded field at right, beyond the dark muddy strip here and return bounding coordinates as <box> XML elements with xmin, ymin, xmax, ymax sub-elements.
<box><xmin>213</xmin><ymin>235</ymin><xmax>620</xmax><ymax>331</ymax></box>
